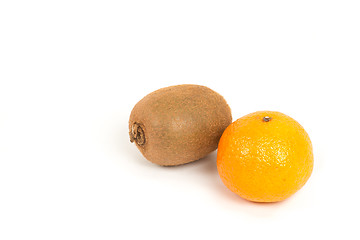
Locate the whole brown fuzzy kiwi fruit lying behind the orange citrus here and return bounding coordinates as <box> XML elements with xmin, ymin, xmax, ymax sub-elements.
<box><xmin>129</xmin><ymin>84</ymin><xmax>232</xmax><ymax>166</ymax></box>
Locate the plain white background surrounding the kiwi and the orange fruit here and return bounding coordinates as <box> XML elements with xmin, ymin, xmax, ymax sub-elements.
<box><xmin>0</xmin><ymin>0</ymin><xmax>360</xmax><ymax>240</ymax></box>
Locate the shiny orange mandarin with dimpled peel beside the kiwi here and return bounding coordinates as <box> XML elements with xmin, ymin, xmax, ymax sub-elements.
<box><xmin>217</xmin><ymin>111</ymin><xmax>314</xmax><ymax>202</ymax></box>
